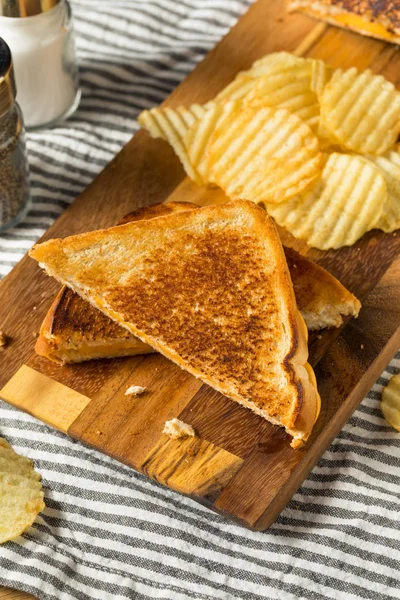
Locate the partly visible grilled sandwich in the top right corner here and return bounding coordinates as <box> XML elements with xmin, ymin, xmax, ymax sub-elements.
<box><xmin>287</xmin><ymin>0</ymin><xmax>400</xmax><ymax>44</ymax></box>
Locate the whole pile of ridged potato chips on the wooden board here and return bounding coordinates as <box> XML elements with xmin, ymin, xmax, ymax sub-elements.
<box><xmin>139</xmin><ymin>52</ymin><xmax>400</xmax><ymax>250</ymax></box>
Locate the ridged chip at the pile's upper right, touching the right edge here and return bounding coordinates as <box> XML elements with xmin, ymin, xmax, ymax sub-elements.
<box><xmin>320</xmin><ymin>68</ymin><xmax>400</xmax><ymax>154</ymax></box>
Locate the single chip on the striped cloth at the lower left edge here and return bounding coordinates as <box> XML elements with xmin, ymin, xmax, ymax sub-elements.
<box><xmin>0</xmin><ymin>438</ymin><xmax>45</xmax><ymax>544</ymax></box>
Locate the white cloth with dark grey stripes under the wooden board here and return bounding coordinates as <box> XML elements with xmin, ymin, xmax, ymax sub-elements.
<box><xmin>0</xmin><ymin>0</ymin><xmax>400</xmax><ymax>600</ymax></box>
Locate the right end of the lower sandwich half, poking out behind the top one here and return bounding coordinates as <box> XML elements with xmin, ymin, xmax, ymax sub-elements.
<box><xmin>284</xmin><ymin>248</ymin><xmax>361</xmax><ymax>331</ymax></box>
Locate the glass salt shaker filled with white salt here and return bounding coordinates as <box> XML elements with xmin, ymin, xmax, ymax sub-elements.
<box><xmin>0</xmin><ymin>0</ymin><xmax>80</xmax><ymax>130</ymax></box>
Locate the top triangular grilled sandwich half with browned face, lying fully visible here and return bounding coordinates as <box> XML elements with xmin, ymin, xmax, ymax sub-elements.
<box><xmin>30</xmin><ymin>201</ymin><xmax>319</xmax><ymax>447</ymax></box>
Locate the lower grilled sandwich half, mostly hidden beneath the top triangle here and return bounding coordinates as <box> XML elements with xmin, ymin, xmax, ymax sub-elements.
<box><xmin>35</xmin><ymin>202</ymin><xmax>361</xmax><ymax>364</ymax></box>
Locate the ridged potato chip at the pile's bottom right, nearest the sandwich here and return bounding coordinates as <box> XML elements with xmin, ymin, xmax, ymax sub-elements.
<box><xmin>266</xmin><ymin>153</ymin><xmax>388</xmax><ymax>250</ymax></box>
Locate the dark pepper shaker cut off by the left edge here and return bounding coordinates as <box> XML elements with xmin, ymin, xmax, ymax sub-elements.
<box><xmin>0</xmin><ymin>38</ymin><xmax>30</xmax><ymax>232</ymax></box>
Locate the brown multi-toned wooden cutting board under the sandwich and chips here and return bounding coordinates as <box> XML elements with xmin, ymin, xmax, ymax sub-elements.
<box><xmin>0</xmin><ymin>0</ymin><xmax>400</xmax><ymax>529</ymax></box>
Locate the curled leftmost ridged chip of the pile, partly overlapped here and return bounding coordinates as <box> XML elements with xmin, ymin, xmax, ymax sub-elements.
<box><xmin>138</xmin><ymin>104</ymin><xmax>205</xmax><ymax>185</ymax></box>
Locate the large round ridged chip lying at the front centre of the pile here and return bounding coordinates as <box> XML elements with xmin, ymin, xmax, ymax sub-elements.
<box><xmin>197</xmin><ymin>101</ymin><xmax>321</xmax><ymax>203</ymax></box>
